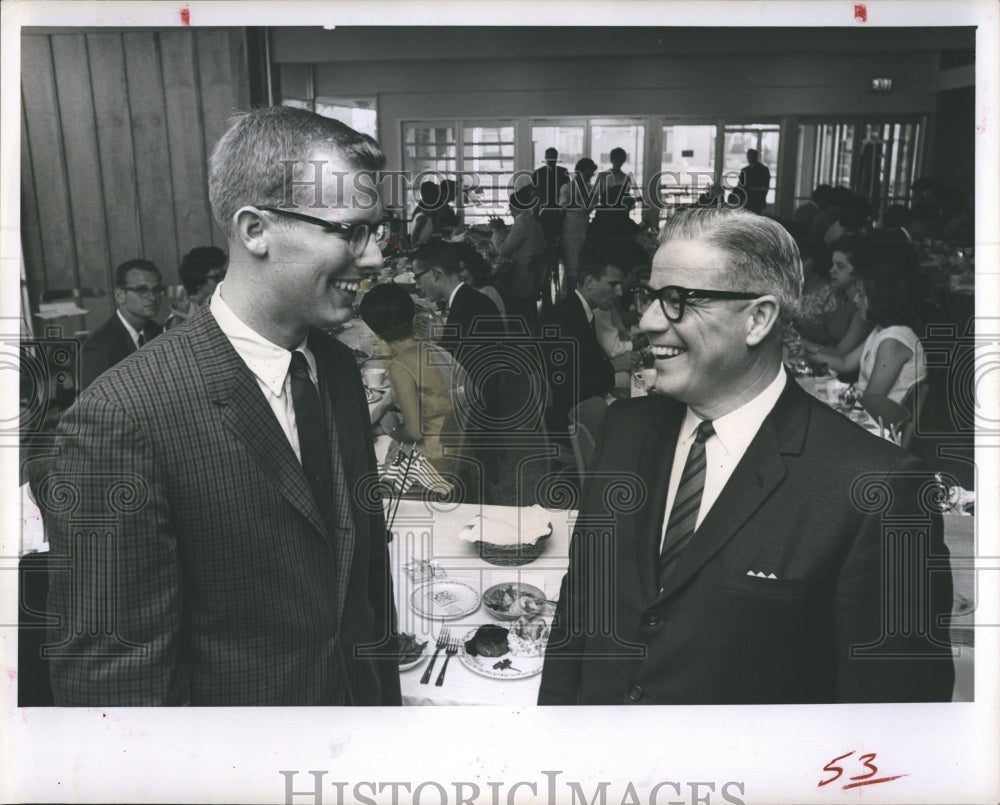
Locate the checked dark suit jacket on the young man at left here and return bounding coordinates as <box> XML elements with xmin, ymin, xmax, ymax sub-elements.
<box><xmin>36</xmin><ymin>309</ymin><xmax>400</xmax><ymax>706</ymax></box>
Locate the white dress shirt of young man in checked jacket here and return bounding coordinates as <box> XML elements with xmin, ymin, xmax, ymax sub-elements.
<box><xmin>209</xmin><ymin>283</ymin><xmax>319</xmax><ymax>463</ymax></box>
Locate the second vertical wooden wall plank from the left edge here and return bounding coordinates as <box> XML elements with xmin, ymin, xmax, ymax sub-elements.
<box><xmin>52</xmin><ymin>35</ymin><xmax>110</xmax><ymax>296</ymax></box>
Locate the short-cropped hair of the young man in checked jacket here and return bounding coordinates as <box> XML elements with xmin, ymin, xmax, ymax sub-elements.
<box><xmin>208</xmin><ymin>106</ymin><xmax>385</xmax><ymax>235</ymax></box>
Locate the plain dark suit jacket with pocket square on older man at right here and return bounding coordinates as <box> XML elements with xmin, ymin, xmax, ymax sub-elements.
<box><xmin>539</xmin><ymin>380</ymin><xmax>954</xmax><ymax>704</ymax></box>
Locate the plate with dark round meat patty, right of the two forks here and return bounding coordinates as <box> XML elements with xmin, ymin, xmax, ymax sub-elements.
<box><xmin>458</xmin><ymin>619</ymin><xmax>549</xmax><ymax>679</ymax></box>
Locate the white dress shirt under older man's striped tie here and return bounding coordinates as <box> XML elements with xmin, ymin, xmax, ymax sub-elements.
<box><xmin>663</xmin><ymin>366</ymin><xmax>787</xmax><ymax>538</ymax></box>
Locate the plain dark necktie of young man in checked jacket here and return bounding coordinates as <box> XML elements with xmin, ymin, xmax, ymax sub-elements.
<box><xmin>289</xmin><ymin>352</ymin><xmax>336</xmax><ymax>534</ymax></box>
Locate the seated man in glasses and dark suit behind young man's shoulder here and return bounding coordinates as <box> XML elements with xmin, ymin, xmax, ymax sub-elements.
<box><xmin>80</xmin><ymin>259</ymin><xmax>166</xmax><ymax>391</ymax></box>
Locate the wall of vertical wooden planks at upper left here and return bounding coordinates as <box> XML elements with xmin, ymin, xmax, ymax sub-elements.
<box><xmin>21</xmin><ymin>28</ymin><xmax>249</xmax><ymax>331</ymax></box>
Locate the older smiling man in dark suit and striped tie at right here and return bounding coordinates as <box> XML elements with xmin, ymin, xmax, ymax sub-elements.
<box><xmin>538</xmin><ymin>208</ymin><xmax>954</xmax><ymax>704</ymax></box>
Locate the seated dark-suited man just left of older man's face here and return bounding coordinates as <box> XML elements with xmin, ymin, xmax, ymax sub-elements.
<box><xmin>542</xmin><ymin>239</ymin><xmax>622</xmax><ymax>433</ymax></box>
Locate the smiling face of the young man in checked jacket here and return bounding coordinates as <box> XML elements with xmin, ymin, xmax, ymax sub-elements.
<box><xmin>264</xmin><ymin>149</ymin><xmax>383</xmax><ymax>337</ymax></box>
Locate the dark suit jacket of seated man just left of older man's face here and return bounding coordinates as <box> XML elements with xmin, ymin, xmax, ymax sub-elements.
<box><xmin>542</xmin><ymin>293</ymin><xmax>615</xmax><ymax>431</ymax></box>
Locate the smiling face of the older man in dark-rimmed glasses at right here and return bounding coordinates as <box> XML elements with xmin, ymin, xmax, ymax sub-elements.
<box><xmin>639</xmin><ymin>239</ymin><xmax>757</xmax><ymax>418</ymax></box>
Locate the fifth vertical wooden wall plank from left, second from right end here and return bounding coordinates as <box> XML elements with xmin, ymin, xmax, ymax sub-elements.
<box><xmin>160</xmin><ymin>31</ymin><xmax>212</xmax><ymax>252</ymax></box>
